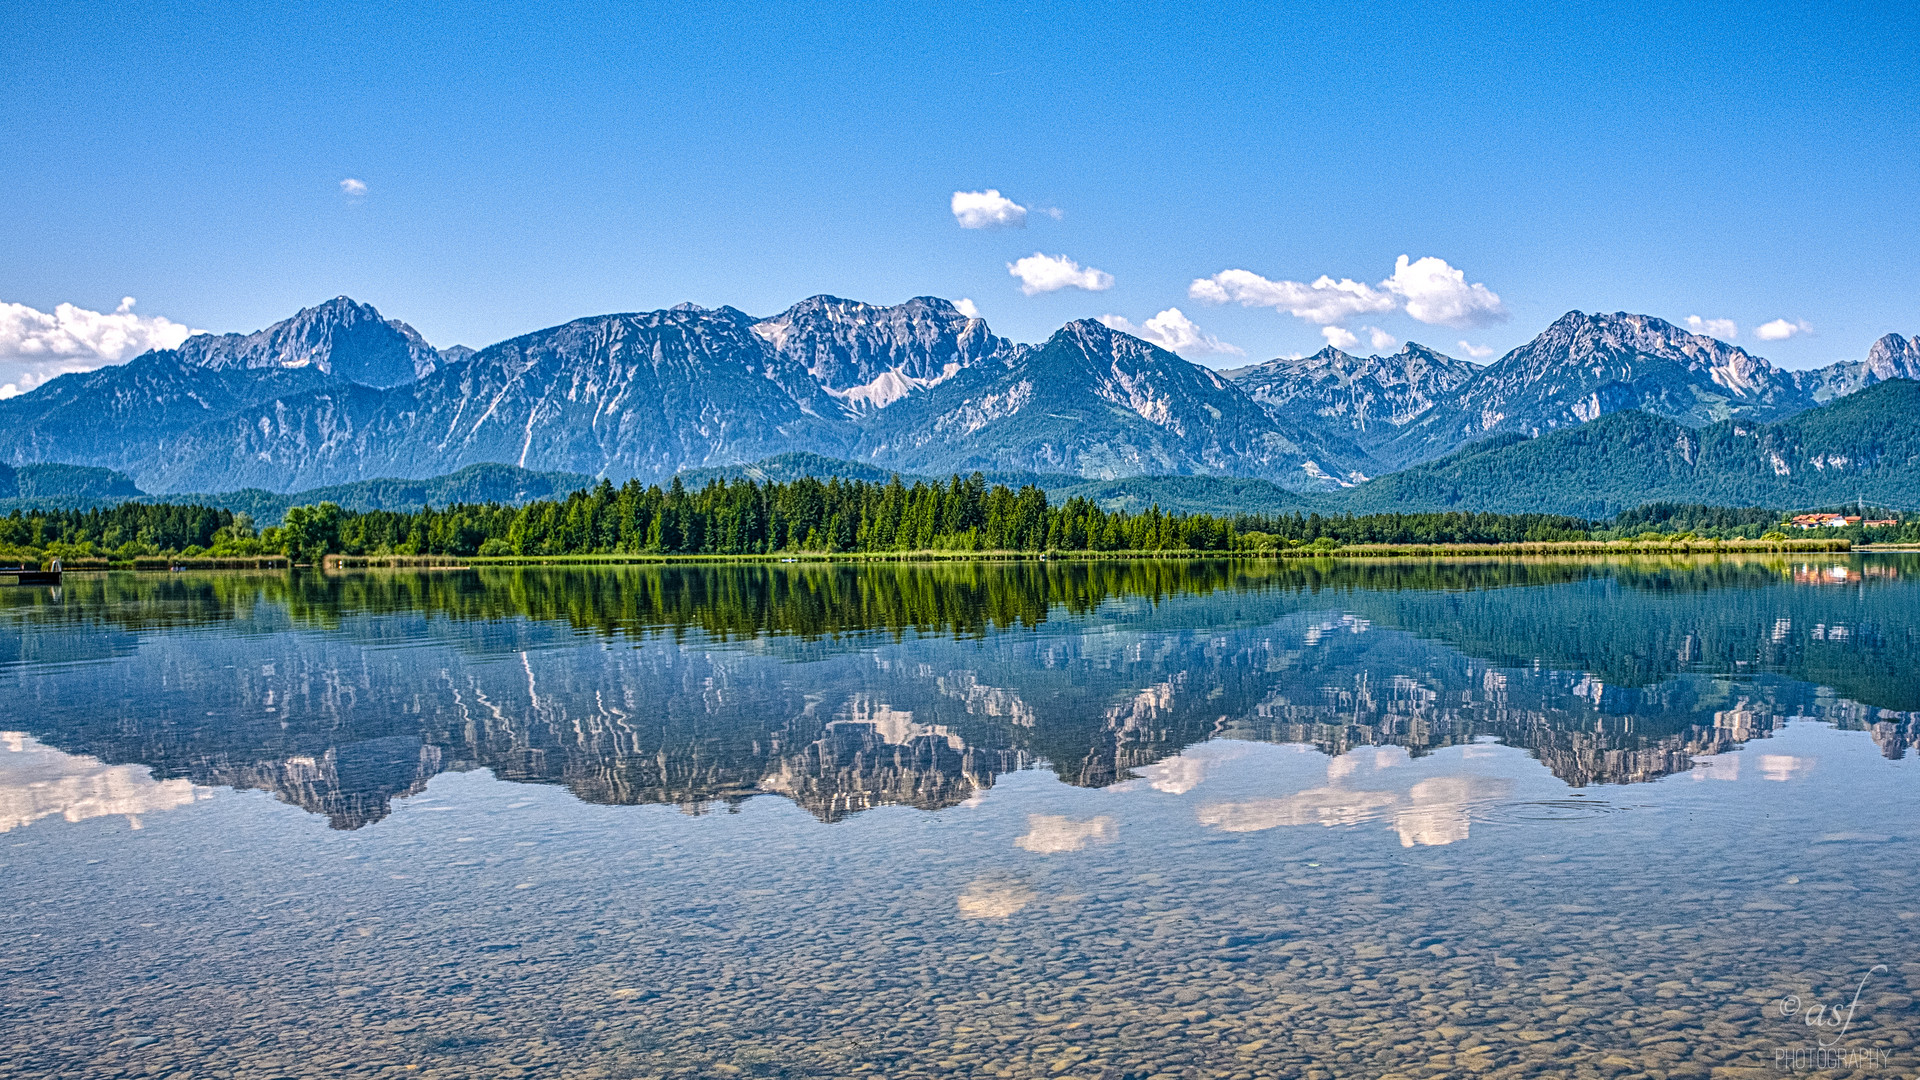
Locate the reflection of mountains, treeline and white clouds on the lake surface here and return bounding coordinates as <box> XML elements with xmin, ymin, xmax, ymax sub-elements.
<box><xmin>0</xmin><ymin>555</ymin><xmax>1920</xmax><ymax>822</ymax></box>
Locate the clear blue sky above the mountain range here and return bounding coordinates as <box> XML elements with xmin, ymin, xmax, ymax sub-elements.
<box><xmin>0</xmin><ymin>0</ymin><xmax>1920</xmax><ymax>386</ymax></box>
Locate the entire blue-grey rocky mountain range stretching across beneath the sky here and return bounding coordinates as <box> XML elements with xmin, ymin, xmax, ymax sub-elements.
<box><xmin>0</xmin><ymin>296</ymin><xmax>1920</xmax><ymax>509</ymax></box>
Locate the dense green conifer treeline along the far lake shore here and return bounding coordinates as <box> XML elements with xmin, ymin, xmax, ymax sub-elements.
<box><xmin>0</xmin><ymin>473</ymin><xmax>1881</xmax><ymax>569</ymax></box>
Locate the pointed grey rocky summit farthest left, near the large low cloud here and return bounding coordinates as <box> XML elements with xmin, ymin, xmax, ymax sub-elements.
<box><xmin>179</xmin><ymin>296</ymin><xmax>451</xmax><ymax>388</ymax></box>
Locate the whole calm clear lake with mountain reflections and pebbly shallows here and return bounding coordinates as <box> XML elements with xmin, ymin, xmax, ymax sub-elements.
<box><xmin>0</xmin><ymin>555</ymin><xmax>1920</xmax><ymax>1078</ymax></box>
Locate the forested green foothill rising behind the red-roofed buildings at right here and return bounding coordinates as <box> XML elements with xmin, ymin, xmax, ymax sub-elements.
<box><xmin>1331</xmin><ymin>379</ymin><xmax>1920</xmax><ymax>517</ymax></box>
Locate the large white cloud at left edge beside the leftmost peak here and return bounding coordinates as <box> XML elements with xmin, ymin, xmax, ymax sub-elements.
<box><xmin>0</xmin><ymin>296</ymin><xmax>202</xmax><ymax>398</ymax></box>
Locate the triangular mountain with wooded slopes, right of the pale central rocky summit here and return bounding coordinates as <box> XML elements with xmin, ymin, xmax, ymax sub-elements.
<box><xmin>856</xmin><ymin>319</ymin><xmax>1371</xmax><ymax>488</ymax></box>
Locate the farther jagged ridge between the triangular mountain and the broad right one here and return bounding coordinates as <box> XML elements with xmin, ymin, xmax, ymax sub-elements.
<box><xmin>1221</xmin><ymin>342</ymin><xmax>1480</xmax><ymax>446</ymax></box>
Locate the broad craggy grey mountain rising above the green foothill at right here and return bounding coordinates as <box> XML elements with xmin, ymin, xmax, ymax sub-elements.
<box><xmin>1380</xmin><ymin>311</ymin><xmax>1812</xmax><ymax>463</ymax></box>
